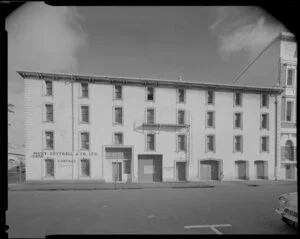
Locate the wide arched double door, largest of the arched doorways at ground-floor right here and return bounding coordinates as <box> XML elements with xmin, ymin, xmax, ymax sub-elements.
<box><xmin>200</xmin><ymin>160</ymin><xmax>219</xmax><ymax>180</ymax></box>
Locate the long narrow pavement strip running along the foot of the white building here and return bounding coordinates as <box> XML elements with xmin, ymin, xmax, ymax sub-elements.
<box><xmin>8</xmin><ymin>180</ymin><xmax>297</xmax><ymax>191</ymax></box>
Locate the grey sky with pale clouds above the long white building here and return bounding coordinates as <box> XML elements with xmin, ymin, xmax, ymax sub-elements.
<box><xmin>6</xmin><ymin>2</ymin><xmax>284</xmax><ymax>153</ymax></box>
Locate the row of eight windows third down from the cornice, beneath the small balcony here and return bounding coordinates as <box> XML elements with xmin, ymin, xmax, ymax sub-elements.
<box><xmin>45</xmin><ymin>131</ymin><xmax>269</xmax><ymax>152</ymax></box>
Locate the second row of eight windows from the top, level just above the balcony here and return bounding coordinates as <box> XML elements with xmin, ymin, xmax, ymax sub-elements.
<box><xmin>45</xmin><ymin>104</ymin><xmax>269</xmax><ymax>129</ymax></box>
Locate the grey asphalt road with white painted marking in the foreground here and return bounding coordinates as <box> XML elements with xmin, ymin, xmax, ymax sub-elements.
<box><xmin>7</xmin><ymin>184</ymin><xmax>297</xmax><ymax>238</ymax></box>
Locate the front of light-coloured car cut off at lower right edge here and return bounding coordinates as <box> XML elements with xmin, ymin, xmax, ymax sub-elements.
<box><xmin>275</xmin><ymin>192</ymin><xmax>298</xmax><ymax>227</ymax></box>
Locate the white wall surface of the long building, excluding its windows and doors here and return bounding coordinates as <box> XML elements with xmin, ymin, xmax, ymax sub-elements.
<box><xmin>25</xmin><ymin>76</ymin><xmax>275</xmax><ymax>181</ymax></box>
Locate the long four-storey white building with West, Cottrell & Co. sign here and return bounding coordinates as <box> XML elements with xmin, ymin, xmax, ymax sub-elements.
<box><xmin>18</xmin><ymin>71</ymin><xmax>282</xmax><ymax>182</ymax></box>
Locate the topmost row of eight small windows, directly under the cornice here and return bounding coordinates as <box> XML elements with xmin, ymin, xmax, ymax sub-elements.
<box><xmin>45</xmin><ymin>81</ymin><xmax>269</xmax><ymax>107</ymax></box>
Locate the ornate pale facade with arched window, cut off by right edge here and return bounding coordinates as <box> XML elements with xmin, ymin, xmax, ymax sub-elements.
<box><xmin>278</xmin><ymin>33</ymin><xmax>297</xmax><ymax>180</ymax></box>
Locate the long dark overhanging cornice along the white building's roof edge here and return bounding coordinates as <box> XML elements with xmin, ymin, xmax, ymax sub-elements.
<box><xmin>17</xmin><ymin>71</ymin><xmax>283</xmax><ymax>94</ymax></box>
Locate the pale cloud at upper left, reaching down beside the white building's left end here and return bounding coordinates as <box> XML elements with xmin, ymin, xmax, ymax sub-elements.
<box><xmin>6</xmin><ymin>2</ymin><xmax>88</xmax><ymax>151</ymax></box>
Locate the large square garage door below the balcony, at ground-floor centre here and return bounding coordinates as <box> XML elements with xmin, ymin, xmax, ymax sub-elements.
<box><xmin>138</xmin><ymin>155</ymin><xmax>162</xmax><ymax>182</ymax></box>
